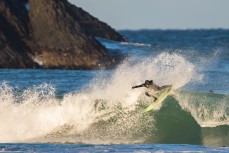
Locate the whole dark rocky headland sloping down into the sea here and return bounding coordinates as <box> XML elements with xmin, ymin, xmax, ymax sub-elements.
<box><xmin>0</xmin><ymin>0</ymin><xmax>124</xmax><ymax>69</ymax></box>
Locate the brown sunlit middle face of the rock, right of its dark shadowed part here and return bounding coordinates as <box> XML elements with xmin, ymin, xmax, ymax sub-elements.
<box><xmin>29</xmin><ymin>0</ymin><xmax>112</xmax><ymax>69</ymax></box>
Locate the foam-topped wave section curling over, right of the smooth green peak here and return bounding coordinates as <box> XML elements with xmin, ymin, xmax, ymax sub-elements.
<box><xmin>176</xmin><ymin>91</ymin><xmax>229</xmax><ymax>127</ymax></box>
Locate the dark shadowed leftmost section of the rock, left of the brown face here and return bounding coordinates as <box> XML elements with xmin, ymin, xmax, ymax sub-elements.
<box><xmin>0</xmin><ymin>0</ymin><xmax>36</xmax><ymax>68</ymax></box>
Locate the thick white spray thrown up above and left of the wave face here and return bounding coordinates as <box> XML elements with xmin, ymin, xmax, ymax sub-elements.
<box><xmin>0</xmin><ymin>53</ymin><xmax>195</xmax><ymax>142</ymax></box>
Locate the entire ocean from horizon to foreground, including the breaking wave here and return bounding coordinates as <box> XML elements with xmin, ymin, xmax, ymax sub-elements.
<box><xmin>0</xmin><ymin>29</ymin><xmax>229</xmax><ymax>152</ymax></box>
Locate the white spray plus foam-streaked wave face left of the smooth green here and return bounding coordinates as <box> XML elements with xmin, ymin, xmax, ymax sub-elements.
<box><xmin>0</xmin><ymin>53</ymin><xmax>196</xmax><ymax>143</ymax></box>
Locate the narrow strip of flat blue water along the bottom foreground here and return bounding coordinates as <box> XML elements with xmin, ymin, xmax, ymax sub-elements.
<box><xmin>0</xmin><ymin>143</ymin><xmax>228</xmax><ymax>153</ymax></box>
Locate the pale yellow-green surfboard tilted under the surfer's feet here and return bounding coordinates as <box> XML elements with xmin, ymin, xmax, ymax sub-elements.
<box><xmin>144</xmin><ymin>87</ymin><xmax>172</xmax><ymax>112</ymax></box>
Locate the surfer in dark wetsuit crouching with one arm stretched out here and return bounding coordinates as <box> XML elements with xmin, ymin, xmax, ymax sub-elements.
<box><xmin>132</xmin><ymin>80</ymin><xmax>172</xmax><ymax>101</ymax></box>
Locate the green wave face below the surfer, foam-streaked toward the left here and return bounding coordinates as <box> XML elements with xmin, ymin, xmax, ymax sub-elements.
<box><xmin>24</xmin><ymin>93</ymin><xmax>229</xmax><ymax>146</ymax></box>
